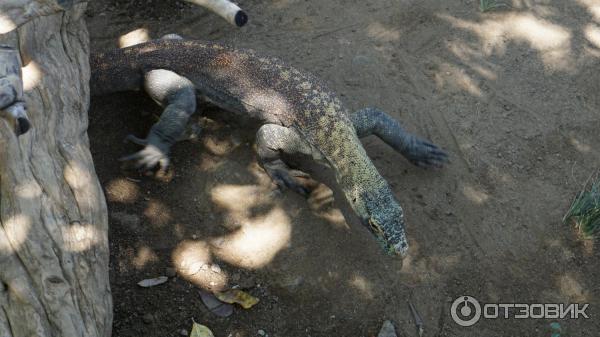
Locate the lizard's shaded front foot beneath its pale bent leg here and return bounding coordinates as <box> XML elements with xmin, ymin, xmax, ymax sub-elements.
<box><xmin>263</xmin><ymin>159</ymin><xmax>312</xmax><ymax>198</ymax></box>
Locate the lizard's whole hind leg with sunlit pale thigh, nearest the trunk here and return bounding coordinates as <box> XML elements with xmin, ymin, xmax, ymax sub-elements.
<box><xmin>120</xmin><ymin>69</ymin><xmax>196</xmax><ymax>171</ymax></box>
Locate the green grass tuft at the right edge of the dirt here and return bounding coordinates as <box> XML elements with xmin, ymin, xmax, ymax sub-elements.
<box><xmin>563</xmin><ymin>174</ymin><xmax>600</xmax><ymax>239</ymax></box>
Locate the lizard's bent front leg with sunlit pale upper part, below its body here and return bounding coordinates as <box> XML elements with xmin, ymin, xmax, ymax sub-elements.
<box><xmin>256</xmin><ymin>124</ymin><xmax>312</xmax><ymax>197</ymax></box>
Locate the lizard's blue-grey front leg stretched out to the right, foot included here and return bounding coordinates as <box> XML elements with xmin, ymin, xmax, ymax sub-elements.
<box><xmin>350</xmin><ymin>108</ymin><xmax>448</xmax><ymax>167</ymax></box>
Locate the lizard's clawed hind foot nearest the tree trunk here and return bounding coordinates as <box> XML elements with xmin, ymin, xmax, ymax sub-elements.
<box><xmin>119</xmin><ymin>135</ymin><xmax>170</xmax><ymax>172</ymax></box>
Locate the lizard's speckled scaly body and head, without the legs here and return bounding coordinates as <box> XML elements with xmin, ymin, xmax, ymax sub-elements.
<box><xmin>91</xmin><ymin>40</ymin><xmax>407</xmax><ymax>254</ymax></box>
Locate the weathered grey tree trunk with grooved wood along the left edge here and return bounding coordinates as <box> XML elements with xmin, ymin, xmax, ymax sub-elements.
<box><xmin>0</xmin><ymin>0</ymin><xmax>112</xmax><ymax>337</ymax></box>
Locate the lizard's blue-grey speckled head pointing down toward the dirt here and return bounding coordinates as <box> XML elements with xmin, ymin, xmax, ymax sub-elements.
<box><xmin>355</xmin><ymin>186</ymin><xmax>408</xmax><ymax>257</ymax></box>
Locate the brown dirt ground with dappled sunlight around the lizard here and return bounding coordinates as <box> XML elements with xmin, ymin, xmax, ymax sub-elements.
<box><xmin>88</xmin><ymin>0</ymin><xmax>600</xmax><ymax>337</ymax></box>
